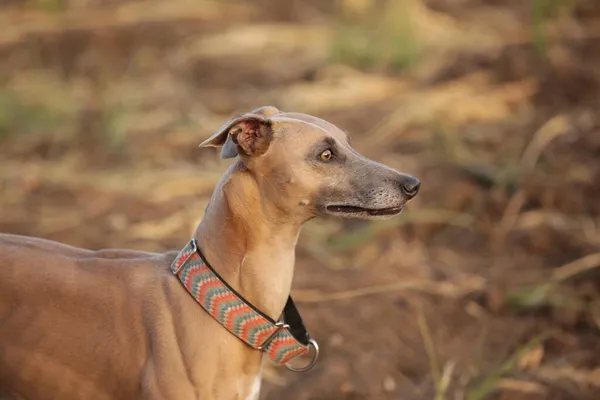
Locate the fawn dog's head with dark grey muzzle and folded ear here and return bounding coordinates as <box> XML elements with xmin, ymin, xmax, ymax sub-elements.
<box><xmin>200</xmin><ymin>106</ymin><xmax>420</xmax><ymax>220</ymax></box>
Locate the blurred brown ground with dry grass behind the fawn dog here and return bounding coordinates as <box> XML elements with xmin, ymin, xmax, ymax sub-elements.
<box><xmin>0</xmin><ymin>0</ymin><xmax>600</xmax><ymax>400</ymax></box>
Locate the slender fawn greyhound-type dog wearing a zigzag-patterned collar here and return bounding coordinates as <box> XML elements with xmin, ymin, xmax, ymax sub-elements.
<box><xmin>0</xmin><ymin>106</ymin><xmax>420</xmax><ymax>400</ymax></box>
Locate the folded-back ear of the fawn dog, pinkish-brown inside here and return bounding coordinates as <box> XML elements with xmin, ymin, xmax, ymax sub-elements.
<box><xmin>200</xmin><ymin>112</ymin><xmax>273</xmax><ymax>158</ymax></box>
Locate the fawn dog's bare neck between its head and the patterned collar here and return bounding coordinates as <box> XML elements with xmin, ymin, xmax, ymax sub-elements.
<box><xmin>195</xmin><ymin>161</ymin><xmax>301</xmax><ymax>320</ymax></box>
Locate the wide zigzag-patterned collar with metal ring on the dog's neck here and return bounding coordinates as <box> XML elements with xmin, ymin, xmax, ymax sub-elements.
<box><xmin>171</xmin><ymin>239</ymin><xmax>319</xmax><ymax>372</ymax></box>
